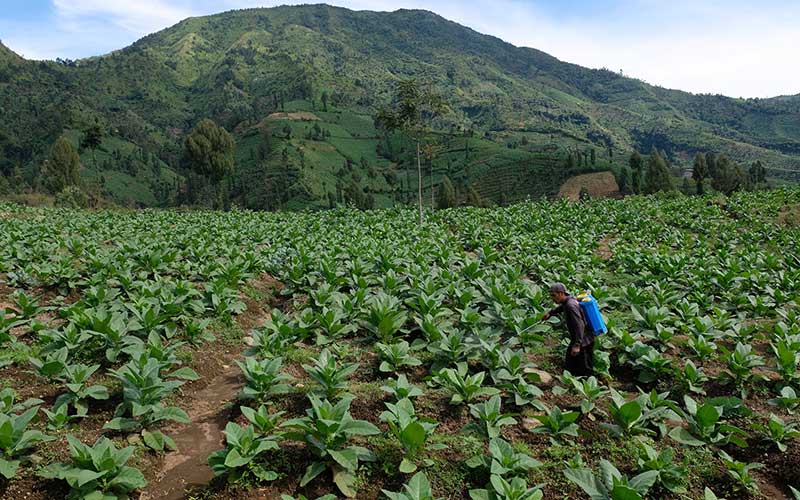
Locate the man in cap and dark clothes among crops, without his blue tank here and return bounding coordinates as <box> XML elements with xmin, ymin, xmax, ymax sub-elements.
<box><xmin>542</xmin><ymin>283</ymin><xmax>594</xmax><ymax>377</ymax></box>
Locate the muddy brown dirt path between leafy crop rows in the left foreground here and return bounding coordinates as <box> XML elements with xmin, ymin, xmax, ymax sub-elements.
<box><xmin>140</xmin><ymin>364</ymin><xmax>243</xmax><ymax>500</ymax></box>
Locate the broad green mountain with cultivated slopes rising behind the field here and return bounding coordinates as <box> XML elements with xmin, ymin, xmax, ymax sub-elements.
<box><xmin>0</xmin><ymin>5</ymin><xmax>800</xmax><ymax>208</ymax></box>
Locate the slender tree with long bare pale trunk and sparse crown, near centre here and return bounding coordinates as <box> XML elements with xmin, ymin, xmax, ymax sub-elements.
<box><xmin>375</xmin><ymin>78</ymin><xmax>445</xmax><ymax>224</ymax></box>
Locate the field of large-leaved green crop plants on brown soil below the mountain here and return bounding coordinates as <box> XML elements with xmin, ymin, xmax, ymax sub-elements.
<box><xmin>0</xmin><ymin>189</ymin><xmax>800</xmax><ymax>500</ymax></box>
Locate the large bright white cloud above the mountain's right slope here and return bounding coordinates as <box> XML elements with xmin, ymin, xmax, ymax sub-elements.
<box><xmin>482</xmin><ymin>0</ymin><xmax>800</xmax><ymax>97</ymax></box>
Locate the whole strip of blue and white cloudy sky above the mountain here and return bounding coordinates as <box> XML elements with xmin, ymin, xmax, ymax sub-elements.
<box><xmin>0</xmin><ymin>0</ymin><xmax>800</xmax><ymax>97</ymax></box>
